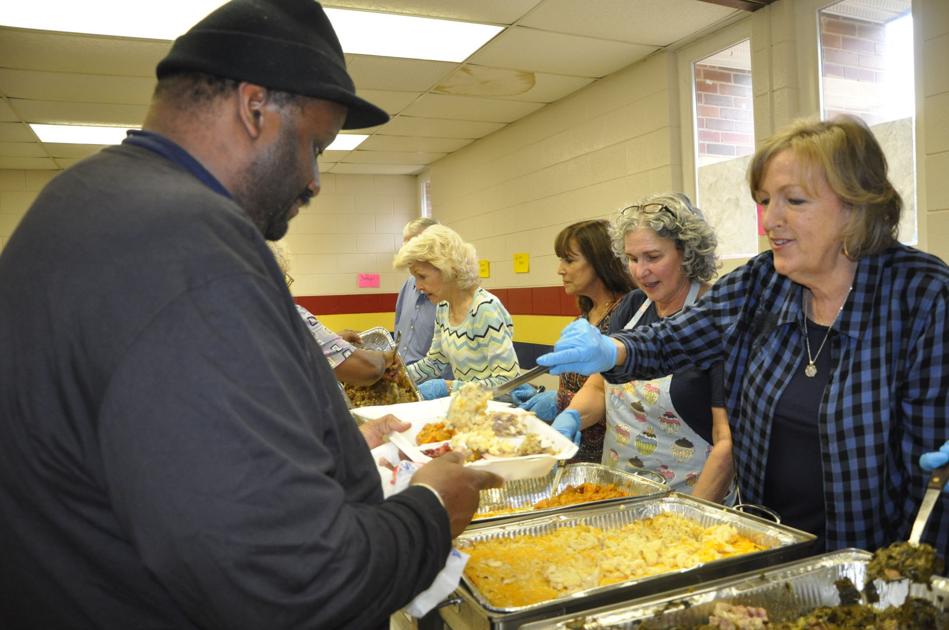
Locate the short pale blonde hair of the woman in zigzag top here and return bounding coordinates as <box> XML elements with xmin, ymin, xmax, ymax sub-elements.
<box><xmin>392</xmin><ymin>225</ymin><xmax>478</xmax><ymax>289</ymax></box>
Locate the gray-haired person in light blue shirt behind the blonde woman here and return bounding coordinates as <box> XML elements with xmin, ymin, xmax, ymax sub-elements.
<box><xmin>395</xmin><ymin>217</ymin><xmax>451</xmax><ymax>378</ymax></box>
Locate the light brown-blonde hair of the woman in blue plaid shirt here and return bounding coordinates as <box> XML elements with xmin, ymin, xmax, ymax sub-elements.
<box><xmin>748</xmin><ymin>115</ymin><xmax>903</xmax><ymax>260</ymax></box>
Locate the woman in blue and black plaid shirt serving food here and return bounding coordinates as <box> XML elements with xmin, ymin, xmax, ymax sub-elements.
<box><xmin>538</xmin><ymin>116</ymin><xmax>949</xmax><ymax>550</ymax></box>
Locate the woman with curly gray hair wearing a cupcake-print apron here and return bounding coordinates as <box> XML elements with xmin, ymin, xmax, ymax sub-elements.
<box><xmin>553</xmin><ymin>193</ymin><xmax>735</xmax><ymax>502</ymax></box>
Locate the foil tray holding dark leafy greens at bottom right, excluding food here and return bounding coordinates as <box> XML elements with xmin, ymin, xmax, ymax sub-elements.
<box><xmin>523</xmin><ymin>549</ymin><xmax>949</xmax><ymax>630</ymax></box>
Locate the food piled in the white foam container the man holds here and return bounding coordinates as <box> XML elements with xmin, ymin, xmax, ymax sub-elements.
<box><xmin>415</xmin><ymin>383</ymin><xmax>557</xmax><ymax>461</ymax></box>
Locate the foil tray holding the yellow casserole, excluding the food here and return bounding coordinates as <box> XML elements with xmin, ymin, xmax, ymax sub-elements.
<box><xmin>441</xmin><ymin>493</ymin><xmax>815</xmax><ymax>628</ymax></box>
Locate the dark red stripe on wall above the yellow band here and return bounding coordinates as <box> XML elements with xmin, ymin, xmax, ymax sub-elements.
<box><xmin>294</xmin><ymin>287</ymin><xmax>580</xmax><ymax>317</ymax></box>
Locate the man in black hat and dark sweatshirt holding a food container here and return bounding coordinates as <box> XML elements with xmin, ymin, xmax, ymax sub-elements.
<box><xmin>0</xmin><ymin>0</ymin><xmax>499</xmax><ymax>629</ymax></box>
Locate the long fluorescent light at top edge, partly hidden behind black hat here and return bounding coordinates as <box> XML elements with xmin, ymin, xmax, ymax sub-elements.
<box><xmin>0</xmin><ymin>0</ymin><xmax>503</xmax><ymax>62</ymax></box>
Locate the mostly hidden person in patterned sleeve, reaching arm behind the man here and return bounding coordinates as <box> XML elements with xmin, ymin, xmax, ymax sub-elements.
<box><xmin>267</xmin><ymin>241</ymin><xmax>395</xmax><ymax>385</ymax></box>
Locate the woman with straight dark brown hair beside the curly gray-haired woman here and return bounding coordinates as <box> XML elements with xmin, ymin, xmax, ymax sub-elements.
<box><xmin>520</xmin><ymin>220</ymin><xmax>635</xmax><ymax>462</ymax></box>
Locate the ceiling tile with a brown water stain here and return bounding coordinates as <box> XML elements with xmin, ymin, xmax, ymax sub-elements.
<box><xmin>469</xmin><ymin>26</ymin><xmax>656</xmax><ymax>78</ymax></box>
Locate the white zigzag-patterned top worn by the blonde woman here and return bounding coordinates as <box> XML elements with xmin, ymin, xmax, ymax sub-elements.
<box><xmin>407</xmin><ymin>287</ymin><xmax>520</xmax><ymax>388</ymax></box>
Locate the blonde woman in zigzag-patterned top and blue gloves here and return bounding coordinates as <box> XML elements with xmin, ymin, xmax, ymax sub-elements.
<box><xmin>393</xmin><ymin>225</ymin><xmax>519</xmax><ymax>400</ymax></box>
